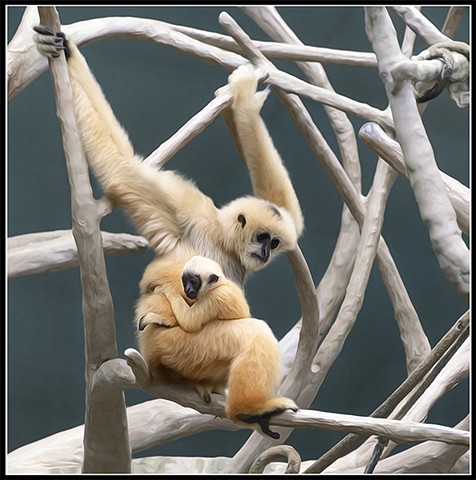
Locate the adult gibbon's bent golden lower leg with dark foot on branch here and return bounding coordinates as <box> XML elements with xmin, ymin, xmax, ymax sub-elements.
<box><xmin>226</xmin><ymin>337</ymin><xmax>298</xmax><ymax>439</ymax></box>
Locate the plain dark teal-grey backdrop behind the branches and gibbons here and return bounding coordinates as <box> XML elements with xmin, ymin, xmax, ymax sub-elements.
<box><xmin>7</xmin><ymin>6</ymin><xmax>469</xmax><ymax>460</ymax></box>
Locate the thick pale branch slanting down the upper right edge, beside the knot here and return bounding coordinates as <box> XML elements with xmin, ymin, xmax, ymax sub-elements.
<box><xmin>365</xmin><ymin>7</ymin><xmax>469</xmax><ymax>296</ymax></box>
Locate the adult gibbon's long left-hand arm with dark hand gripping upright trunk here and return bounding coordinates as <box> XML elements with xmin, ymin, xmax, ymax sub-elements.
<box><xmin>34</xmin><ymin>26</ymin><xmax>216</xmax><ymax>253</ymax></box>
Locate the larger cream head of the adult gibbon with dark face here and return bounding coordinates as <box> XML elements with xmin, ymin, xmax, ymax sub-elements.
<box><xmin>219</xmin><ymin>197</ymin><xmax>297</xmax><ymax>272</ymax></box>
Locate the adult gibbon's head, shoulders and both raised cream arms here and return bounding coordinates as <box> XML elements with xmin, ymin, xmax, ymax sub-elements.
<box><xmin>34</xmin><ymin>26</ymin><xmax>303</xmax><ymax>285</ymax></box>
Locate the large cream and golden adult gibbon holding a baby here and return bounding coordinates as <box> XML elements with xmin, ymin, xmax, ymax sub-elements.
<box><xmin>34</xmin><ymin>26</ymin><xmax>304</xmax><ymax>436</ymax></box>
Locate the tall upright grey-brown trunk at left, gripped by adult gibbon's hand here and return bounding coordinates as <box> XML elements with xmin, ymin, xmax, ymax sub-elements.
<box><xmin>38</xmin><ymin>7</ymin><xmax>131</xmax><ymax>473</ymax></box>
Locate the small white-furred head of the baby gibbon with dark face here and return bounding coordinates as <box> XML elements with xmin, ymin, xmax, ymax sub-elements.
<box><xmin>182</xmin><ymin>255</ymin><xmax>223</xmax><ymax>300</ymax></box>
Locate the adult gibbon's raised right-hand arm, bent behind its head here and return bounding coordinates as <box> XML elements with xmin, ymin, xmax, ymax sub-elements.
<box><xmin>228</xmin><ymin>64</ymin><xmax>304</xmax><ymax>237</ymax></box>
